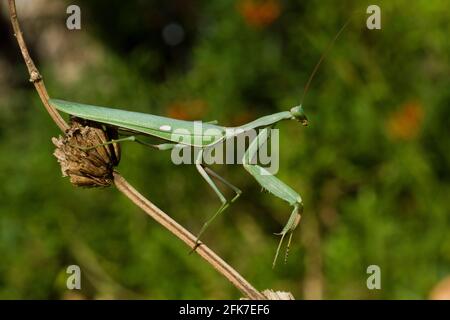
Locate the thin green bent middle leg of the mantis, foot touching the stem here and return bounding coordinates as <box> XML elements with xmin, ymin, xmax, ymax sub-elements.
<box><xmin>192</xmin><ymin>151</ymin><xmax>242</xmax><ymax>251</ymax></box>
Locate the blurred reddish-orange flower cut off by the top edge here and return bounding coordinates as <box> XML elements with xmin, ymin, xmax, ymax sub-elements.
<box><xmin>237</xmin><ymin>0</ymin><xmax>281</xmax><ymax>27</ymax></box>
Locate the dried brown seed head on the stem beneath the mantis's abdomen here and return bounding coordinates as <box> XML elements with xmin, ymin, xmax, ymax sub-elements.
<box><xmin>52</xmin><ymin>118</ymin><xmax>120</xmax><ymax>187</ymax></box>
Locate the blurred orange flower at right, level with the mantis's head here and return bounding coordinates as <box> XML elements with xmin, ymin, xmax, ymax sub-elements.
<box><xmin>387</xmin><ymin>101</ymin><xmax>423</xmax><ymax>140</ymax></box>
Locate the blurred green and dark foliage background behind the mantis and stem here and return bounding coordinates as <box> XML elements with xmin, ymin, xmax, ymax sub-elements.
<box><xmin>0</xmin><ymin>0</ymin><xmax>450</xmax><ymax>299</ymax></box>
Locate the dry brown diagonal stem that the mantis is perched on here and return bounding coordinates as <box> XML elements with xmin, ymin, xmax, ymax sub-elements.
<box><xmin>8</xmin><ymin>0</ymin><xmax>270</xmax><ymax>300</ymax></box>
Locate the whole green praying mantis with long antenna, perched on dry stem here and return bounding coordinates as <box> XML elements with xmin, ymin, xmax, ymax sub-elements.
<box><xmin>49</xmin><ymin>19</ymin><xmax>350</xmax><ymax>266</ymax></box>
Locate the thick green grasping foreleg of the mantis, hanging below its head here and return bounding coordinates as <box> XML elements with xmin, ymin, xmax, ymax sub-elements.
<box><xmin>242</xmin><ymin>128</ymin><xmax>303</xmax><ymax>266</ymax></box>
